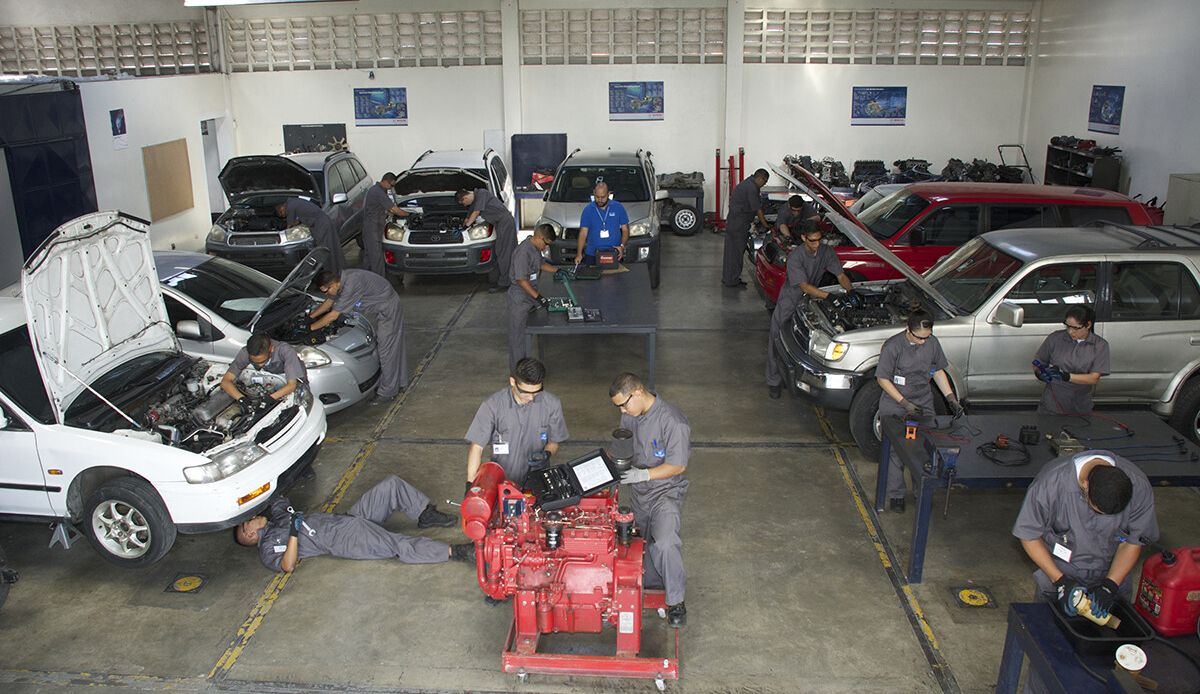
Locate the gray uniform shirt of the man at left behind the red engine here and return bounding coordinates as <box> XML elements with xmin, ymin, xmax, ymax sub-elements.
<box><xmin>466</xmin><ymin>388</ymin><xmax>570</xmax><ymax>485</ymax></box>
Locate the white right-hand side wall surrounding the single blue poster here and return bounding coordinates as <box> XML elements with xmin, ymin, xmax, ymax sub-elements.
<box><xmin>1026</xmin><ymin>0</ymin><xmax>1200</xmax><ymax>202</ymax></box>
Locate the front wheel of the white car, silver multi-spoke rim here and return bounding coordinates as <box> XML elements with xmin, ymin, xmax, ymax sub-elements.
<box><xmin>83</xmin><ymin>477</ymin><xmax>175</xmax><ymax>569</ymax></box>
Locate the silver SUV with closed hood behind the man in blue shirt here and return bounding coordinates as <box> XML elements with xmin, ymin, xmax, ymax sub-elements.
<box><xmin>538</xmin><ymin>149</ymin><xmax>671</xmax><ymax>287</ymax></box>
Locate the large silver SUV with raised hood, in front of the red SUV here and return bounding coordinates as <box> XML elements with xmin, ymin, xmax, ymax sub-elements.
<box><xmin>775</xmin><ymin>163</ymin><xmax>1200</xmax><ymax>456</ymax></box>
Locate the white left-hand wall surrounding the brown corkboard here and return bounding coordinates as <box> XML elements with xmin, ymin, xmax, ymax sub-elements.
<box><xmin>79</xmin><ymin>74</ymin><xmax>226</xmax><ymax>250</ymax></box>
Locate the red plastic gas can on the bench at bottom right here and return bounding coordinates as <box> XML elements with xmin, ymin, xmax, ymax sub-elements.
<box><xmin>1134</xmin><ymin>548</ymin><xmax>1200</xmax><ymax>636</ymax></box>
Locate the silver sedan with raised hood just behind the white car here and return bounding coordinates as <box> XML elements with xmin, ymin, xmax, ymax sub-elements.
<box><xmin>154</xmin><ymin>250</ymin><xmax>379</xmax><ymax>413</ymax></box>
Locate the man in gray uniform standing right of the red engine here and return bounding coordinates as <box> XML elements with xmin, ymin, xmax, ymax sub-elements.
<box><xmin>608</xmin><ymin>372</ymin><xmax>691</xmax><ymax>628</ymax></box>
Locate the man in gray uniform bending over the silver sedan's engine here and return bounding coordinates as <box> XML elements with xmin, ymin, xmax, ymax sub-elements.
<box><xmin>308</xmin><ymin>269</ymin><xmax>408</xmax><ymax>405</ymax></box>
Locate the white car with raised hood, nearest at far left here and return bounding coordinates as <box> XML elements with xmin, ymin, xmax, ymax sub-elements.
<box><xmin>0</xmin><ymin>211</ymin><xmax>325</xmax><ymax>567</ymax></box>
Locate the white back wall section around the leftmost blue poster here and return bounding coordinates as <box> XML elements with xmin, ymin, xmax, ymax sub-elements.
<box><xmin>226</xmin><ymin>66</ymin><xmax>504</xmax><ymax>177</ymax></box>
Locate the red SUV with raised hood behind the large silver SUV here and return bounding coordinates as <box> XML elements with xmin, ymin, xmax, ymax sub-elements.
<box><xmin>754</xmin><ymin>160</ymin><xmax>1152</xmax><ymax>304</ymax></box>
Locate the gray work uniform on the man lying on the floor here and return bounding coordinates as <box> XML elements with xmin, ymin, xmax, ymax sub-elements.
<box><xmin>258</xmin><ymin>474</ymin><xmax>450</xmax><ymax>572</ymax></box>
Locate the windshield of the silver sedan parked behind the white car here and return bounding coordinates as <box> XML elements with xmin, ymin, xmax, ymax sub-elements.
<box><xmin>163</xmin><ymin>258</ymin><xmax>298</xmax><ymax>329</ymax></box>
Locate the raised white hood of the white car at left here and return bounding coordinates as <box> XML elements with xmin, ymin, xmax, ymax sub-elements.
<box><xmin>20</xmin><ymin>211</ymin><xmax>179</xmax><ymax>423</ymax></box>
